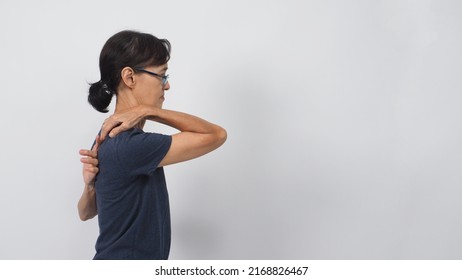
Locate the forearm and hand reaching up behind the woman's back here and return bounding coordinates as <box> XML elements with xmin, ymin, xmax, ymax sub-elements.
<box><xmin>77</xmin><ymin>136</ymin><xmax>100</xmax><ymax>221</ymax></box>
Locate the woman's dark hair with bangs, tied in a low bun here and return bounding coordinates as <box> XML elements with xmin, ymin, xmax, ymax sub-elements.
<box><xmin>88</xmin><ymin>30</ymin><xmax>171</xmax><ymax>113</ymax></box>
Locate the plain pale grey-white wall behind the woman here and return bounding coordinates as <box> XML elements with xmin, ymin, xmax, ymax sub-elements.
<box><xmin>0</xmin><ymin>0</ymin><xmax>462</xmax><ymax>259</ymax></box>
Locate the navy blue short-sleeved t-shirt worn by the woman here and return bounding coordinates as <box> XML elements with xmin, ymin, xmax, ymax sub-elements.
<box><xmin>94</xmin><ymin>128</ymin><xmax>172</xmax><ymax>260</ymax></box>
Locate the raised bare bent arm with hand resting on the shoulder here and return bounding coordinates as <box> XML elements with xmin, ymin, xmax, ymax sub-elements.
<box><xmin>101</xmin><ymin>106</ymin><xmax>227</xmax><ymax>166</ymax></box>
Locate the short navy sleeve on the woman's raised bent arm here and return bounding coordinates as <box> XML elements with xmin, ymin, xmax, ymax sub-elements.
<box><xmin>117</xmin><ymin>129</ymin><xmax>172</xmax><ymax>175</ymax></box>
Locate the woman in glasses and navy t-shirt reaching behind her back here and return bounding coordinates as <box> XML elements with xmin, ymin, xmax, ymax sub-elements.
<box><xmin>78</xmin><ymin>31</ymin><xmax>226</xmax><ymax>259</ymax></box>
